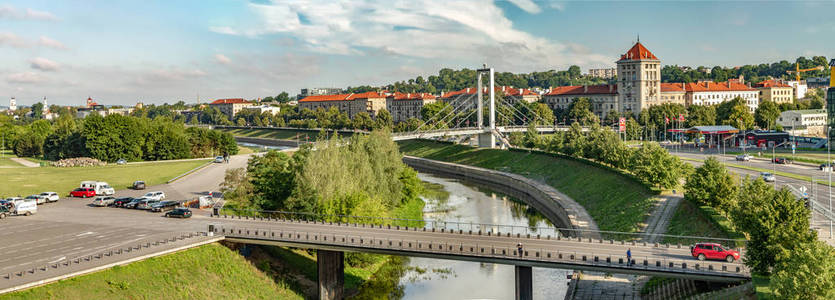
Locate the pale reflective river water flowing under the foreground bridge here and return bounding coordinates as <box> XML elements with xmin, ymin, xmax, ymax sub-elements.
<box><xmin>400</xmin><ymin>173</ymin><xmax>571</xmax><ymax>299</ymax></box>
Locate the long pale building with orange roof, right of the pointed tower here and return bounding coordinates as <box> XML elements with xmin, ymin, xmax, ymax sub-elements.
<box><xmin>685</xmin><ymin>79</ymin><xmax>760</xmax><ymax>113</ymax></box>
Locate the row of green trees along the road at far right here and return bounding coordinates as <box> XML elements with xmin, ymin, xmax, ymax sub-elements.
<box><xmin>684</xmin><ymin>157</ymin><xmax>835</xmax><ymax>299</ymax></box>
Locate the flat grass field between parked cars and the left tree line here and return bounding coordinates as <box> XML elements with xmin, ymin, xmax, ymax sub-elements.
<box><xmin>0</xmin><ymin>160</ymin><xmax>208</xmax><ymax>197</ymax></box>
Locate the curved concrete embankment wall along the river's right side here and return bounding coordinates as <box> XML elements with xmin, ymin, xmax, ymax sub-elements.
<box><xmin>403</xmin><ymin>156</ymin><xmax>598</xmax><ymax>236</ymax></box>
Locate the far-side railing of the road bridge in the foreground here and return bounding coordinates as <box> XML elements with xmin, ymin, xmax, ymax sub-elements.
<box><xmin>219</xmin><ymin>207</ymin><xmax>747</xmax><ymax>250</ymax></box>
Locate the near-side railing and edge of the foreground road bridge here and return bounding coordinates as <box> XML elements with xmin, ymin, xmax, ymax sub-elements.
<box><xmin>212</xmin><ymin>225</ymin><xmax>749</xmax><ymax>276</ymax></box>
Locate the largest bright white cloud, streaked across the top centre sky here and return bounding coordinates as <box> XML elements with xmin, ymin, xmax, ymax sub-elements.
<box><xmin>210</xmin><ymin>0</ymin><xmax>613</xmax><ymax>71</ymax></box>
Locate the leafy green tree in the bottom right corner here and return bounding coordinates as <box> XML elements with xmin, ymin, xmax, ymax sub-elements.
<box><xmin>769</xmin><ymin>241</ymin><xmax>835</xmax><ymax>299</ymax></box>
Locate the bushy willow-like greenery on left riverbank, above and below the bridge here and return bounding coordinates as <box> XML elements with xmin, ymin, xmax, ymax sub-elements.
<box><xmin>222</xmin><ymin>131</ymin><xmax>423</xmax><ymax>295</ymax></box>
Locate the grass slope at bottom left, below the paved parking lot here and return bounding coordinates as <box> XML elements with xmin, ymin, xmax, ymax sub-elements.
<box><xmin>0</xmin><ymin>244</ymin><xmax>303</xmax><ymax>299</ymax></box>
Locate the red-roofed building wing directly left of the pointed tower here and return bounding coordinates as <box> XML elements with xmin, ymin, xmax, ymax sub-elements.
<box><xmin>542</xmin><ymin>84</ymin><xmax>618</xmax><ymax>120</ymax></box>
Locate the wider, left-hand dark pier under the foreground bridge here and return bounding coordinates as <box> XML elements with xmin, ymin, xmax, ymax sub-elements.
<box><xmin>316</xmin><ymin>250</ymin><xmax>345</xmax><ymax>300</ymax></box>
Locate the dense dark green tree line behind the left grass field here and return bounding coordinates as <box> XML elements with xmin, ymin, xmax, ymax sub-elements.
<box><xmin>2</xmin><ymin>113</ymin><xmax>238</xmax><ymax>162</ymax></box>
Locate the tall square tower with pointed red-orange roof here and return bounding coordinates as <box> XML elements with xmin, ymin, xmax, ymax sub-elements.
<box><xmin>616</xmin><ymin>39</ymin><xmax>661</xmax><ymax>117</ymax></box>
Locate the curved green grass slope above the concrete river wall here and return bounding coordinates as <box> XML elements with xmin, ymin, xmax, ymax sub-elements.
<box><xmin>400</xmin><ymin>140</ymin><xmax>653</xmax><ymax>232</ymax></box>
